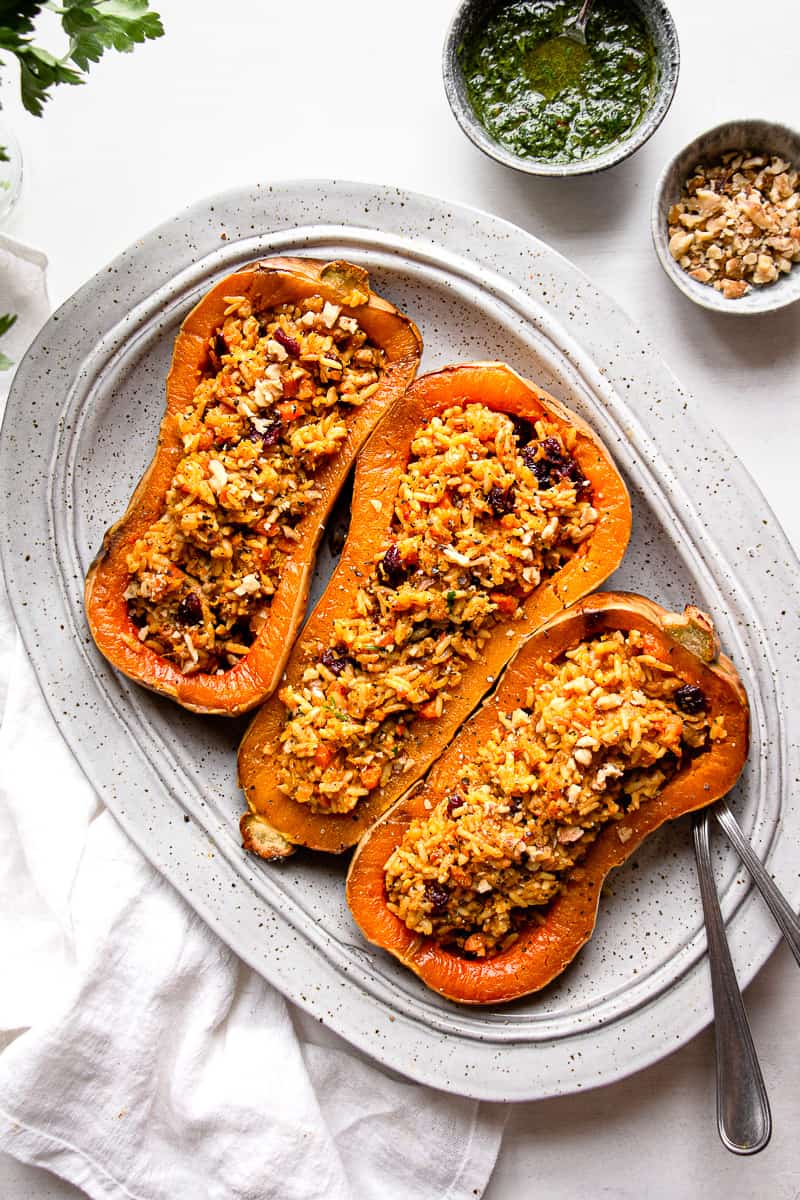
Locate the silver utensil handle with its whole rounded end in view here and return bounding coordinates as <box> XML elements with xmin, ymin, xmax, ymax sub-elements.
<box><xmin>693</xmin><ymin>811</ymin><xmax>772</xmax><ymax>1154</ymax></box>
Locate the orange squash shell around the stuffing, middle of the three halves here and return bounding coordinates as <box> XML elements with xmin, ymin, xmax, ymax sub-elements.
<box><xmin>239</xmin><ymin>362</ymin><xmax>631</xmax><ymax>858</ymax></box>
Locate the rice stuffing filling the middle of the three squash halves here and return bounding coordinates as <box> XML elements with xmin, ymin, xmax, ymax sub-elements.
<box><xmin>277</xmin><ymin>402</ymin><xmax>599</xmax><ymax>812</ymax></box>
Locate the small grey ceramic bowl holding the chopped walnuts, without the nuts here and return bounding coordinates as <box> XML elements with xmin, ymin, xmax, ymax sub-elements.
<box><xmin>650</xmin><ymin>120</ymin><xmax>800</xmax><ymax>317</ymax></box>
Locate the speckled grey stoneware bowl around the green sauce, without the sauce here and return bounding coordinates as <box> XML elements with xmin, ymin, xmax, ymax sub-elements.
<box><xmin>441</xmin><ymin>0</ymin><xmax>680</xmax><ymax>178</ymax></box>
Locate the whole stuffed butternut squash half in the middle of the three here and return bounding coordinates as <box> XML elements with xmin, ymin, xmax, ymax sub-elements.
<box><xmin>239</xmin><ymin>362</ymin><xmax>631</xmax><ymax>858</ymax></box>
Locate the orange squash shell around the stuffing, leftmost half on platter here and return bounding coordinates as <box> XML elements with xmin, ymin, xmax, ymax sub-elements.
<box><xmin>84</xmin><ymin>258</ymin><xmax>422</xmax><ymax>716</ymax></box>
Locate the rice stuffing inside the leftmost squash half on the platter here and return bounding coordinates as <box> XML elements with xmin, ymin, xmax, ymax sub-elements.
<box><xmin>125</xmin><ymin>295</ymin><xmax>384</xmax><ymax>674</ymax></box>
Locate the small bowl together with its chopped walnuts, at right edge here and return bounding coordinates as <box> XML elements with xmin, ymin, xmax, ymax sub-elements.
<box><xmin>651</xmin><ymin>120</ymin><xmax>800</xmax><ymax>316</ymax></box>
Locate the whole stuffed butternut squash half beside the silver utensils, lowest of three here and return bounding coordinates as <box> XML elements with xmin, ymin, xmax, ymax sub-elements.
<box><xmin>347</xmin><ymin>593</ymin><xmax>748</xmax><ymax>1004</ymax></box>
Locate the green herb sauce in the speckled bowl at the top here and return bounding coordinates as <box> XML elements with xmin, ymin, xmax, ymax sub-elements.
<box><xmin>458</xmin><ymin>0</ymin><xmax>656</xmax><ymax>162</ymax></box>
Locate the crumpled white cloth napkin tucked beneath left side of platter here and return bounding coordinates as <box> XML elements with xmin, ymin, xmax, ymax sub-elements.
<box><xmin>0</xmin><ymin>242</ymin><xmax>505</xmax><ymax>1200</ymax></box>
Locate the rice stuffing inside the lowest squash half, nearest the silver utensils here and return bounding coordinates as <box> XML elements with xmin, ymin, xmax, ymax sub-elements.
<box><xmin>385</xmin><ymin>630</ymin><xmax>726</xmax><ymax>958</ymax></box>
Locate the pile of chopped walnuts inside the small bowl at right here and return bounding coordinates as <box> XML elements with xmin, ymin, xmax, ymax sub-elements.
<box><xmin>667</xmin><ymin>150</ymin><xmax>800</xmax><ymax>300</ymax></box>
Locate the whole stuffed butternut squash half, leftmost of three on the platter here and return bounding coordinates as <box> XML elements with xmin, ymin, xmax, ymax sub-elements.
<box><xmin>85</xmin><ymin>258</ymin><xmax>422</xmax><ymax>716</ymax></box>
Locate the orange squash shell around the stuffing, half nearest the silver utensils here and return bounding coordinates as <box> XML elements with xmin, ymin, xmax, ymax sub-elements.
<box><xmin>347</xmin><ymin>593</ymin><xmax>748</xmax><ymax>1004</ymax></box>
